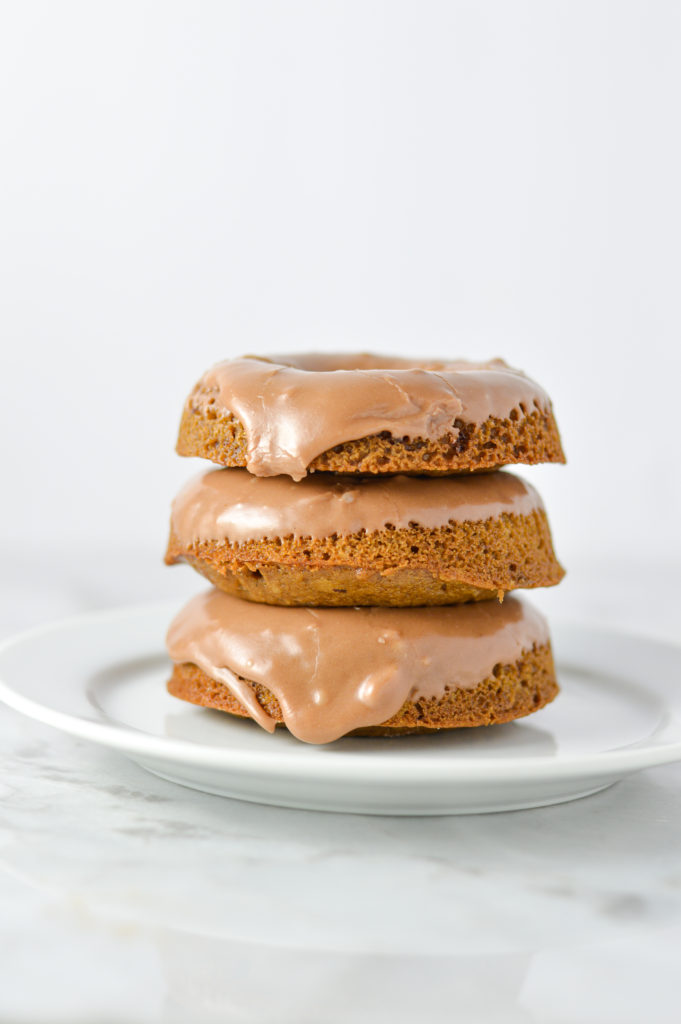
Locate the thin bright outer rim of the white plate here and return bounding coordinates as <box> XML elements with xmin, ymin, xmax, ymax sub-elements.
<box><xmin>0</xmin><ymin>600</ymin><xmax>681</xmax><ymax>784</ymax></box>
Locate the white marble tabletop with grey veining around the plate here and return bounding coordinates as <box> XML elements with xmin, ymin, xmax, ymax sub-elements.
<box><xmin>0</xmin><ymin>554</ymin><xmax>681</xmax><ymax>1024</ymax></box>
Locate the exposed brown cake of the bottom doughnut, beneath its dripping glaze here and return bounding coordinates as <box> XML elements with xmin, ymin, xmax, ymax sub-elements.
<box><xmin>168</xmin><ymin>644</ymin><xmax>558</xmax><ymax>736</ymax></box>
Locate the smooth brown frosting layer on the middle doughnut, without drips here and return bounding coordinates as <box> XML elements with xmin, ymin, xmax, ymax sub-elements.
<box><xmin>171</xmin><ymin>469</ymin><xmax>543</xmax><ymax>547</ymax></box>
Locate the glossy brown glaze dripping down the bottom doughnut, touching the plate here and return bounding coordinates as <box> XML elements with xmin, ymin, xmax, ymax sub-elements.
<box><xmin>167</xmin><ymin>590</ymin><xmax>549</xmax><ymax>743</ymax></box>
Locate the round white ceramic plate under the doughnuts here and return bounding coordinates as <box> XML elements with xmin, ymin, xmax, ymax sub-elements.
<box><xmin>0</xmin><ymin>604</ymin><xmax>681</xmax><ymax>814</ymax></box>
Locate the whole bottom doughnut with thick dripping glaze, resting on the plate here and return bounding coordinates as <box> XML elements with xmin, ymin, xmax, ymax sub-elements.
<box><xmin>167</xmin><ymin>589</ymin><xmax>558</xmax><ymax>743</ymax></box>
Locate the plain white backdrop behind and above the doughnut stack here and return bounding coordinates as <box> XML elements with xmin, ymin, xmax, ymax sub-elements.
<box><xmin>0</xmin><ymin>0</ymin><xmax>681</xmax><ymax>603</ymax></box>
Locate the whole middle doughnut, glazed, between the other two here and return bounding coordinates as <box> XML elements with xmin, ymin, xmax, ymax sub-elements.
<box><xmin>166</xmin><ymin>469</ymin><xmax>564</xmax><ymax>606</ymax></box>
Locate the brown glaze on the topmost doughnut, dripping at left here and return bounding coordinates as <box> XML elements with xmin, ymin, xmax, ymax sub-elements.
<box><xmin>187</xmin><ymin>353</ymin><xmax>551</xmax><ymax>480</ymax></box>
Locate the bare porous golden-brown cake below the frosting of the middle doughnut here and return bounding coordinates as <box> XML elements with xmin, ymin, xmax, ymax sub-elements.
<box><xmin>166</xmin><ymin>509</ymin><xmax>564</xmax><ymax>606</ymax></box>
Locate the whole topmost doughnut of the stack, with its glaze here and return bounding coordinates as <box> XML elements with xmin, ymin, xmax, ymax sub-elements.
<box><xmin>177</xmin><ymin>352</ymin><xmax>565</xmax><ymax>480</ymax></box>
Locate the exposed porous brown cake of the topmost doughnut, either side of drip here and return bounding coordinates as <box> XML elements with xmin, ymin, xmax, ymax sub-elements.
<box><xmin>176</xmin><ymin>403</ymin><xmax>565</xmax><ymax>475</ymax></box>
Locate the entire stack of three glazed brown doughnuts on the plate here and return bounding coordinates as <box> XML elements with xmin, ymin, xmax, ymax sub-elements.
<box><xmin>166</xmin><ymin>353</ymin><xmax>565</xmax><ymax>743</ymax></box>
